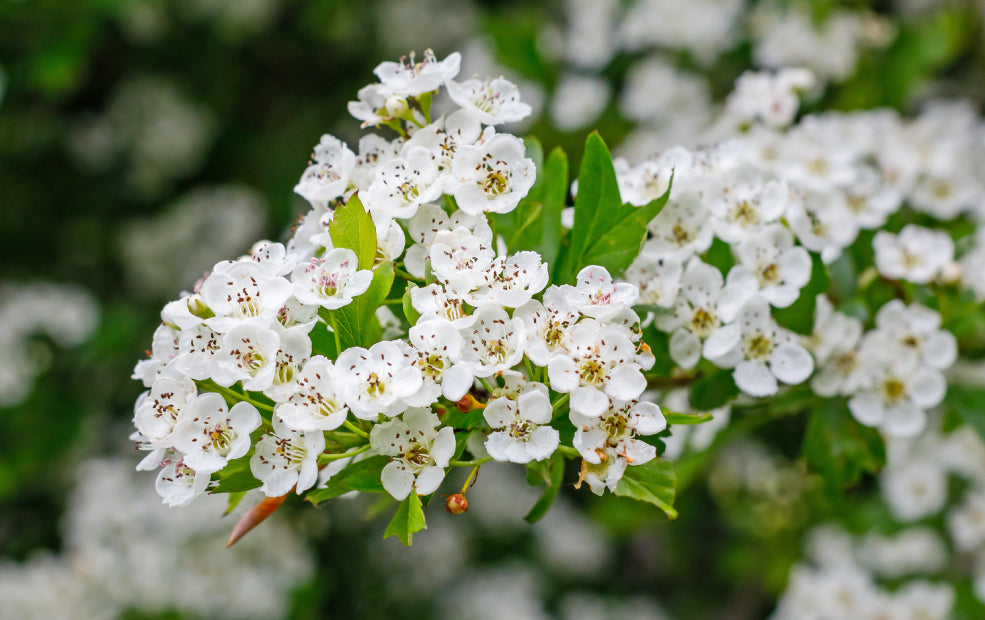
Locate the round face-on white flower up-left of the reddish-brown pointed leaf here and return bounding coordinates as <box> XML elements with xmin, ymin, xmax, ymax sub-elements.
<box><xmin>173</xmin><ymin>392</ymin><xmax>260</xmax><ymax>473</ymax></box>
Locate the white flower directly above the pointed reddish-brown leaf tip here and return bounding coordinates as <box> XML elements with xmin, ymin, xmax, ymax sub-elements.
<box><xmin>250</xmin><ymin>415</ymin><xmax>325</xmax><ymax>497</ymax></box>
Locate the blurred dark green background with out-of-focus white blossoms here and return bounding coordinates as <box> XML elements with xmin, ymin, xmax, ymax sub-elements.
<box><xmin>0</xmin><ymin>0</ymin><xmax>985</xmax><ymax>620</ymax></box>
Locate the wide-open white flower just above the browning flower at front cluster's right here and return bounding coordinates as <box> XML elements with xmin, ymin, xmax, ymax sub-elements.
<box><xmin>547</xmin><ymin>319</ymin><xmax>646</xmax><ymax>416</ymax></box>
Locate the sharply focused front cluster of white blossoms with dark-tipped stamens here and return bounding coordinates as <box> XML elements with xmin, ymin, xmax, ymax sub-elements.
<box><xmin>133</xmin><ymin>51</ymin><xmax>666</xmax><ymax>532</ymax></box>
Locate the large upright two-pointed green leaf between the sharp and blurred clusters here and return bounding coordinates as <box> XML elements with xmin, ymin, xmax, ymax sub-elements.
<box><xmin>561</xmin><ymin>132</ymin><xmax>670</xmax><ymax>281</ymax></box>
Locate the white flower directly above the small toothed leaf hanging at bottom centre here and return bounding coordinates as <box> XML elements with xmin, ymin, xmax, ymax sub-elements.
<box><xmin>369</xmin><ymin>408</ymin><xmax>455</xmax><ymax>501</ymax></box>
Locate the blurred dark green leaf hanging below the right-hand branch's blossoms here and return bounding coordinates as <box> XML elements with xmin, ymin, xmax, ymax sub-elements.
<box><xmin>803</xmin><ymin>398</ymin><xmax>886</xmax><ymax>503</ymax></box>
